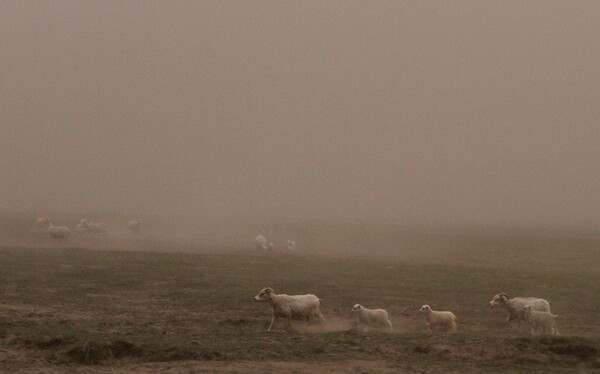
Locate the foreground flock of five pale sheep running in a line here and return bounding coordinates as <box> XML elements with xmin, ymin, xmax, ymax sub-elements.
<box><xmin>254</xmin><ymin>287</ymin><xmax>558</xmax><ymax>336</ymax></box>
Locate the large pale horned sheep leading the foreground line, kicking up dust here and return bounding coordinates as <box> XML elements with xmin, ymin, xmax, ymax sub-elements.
<box><xmin>254</xmin><ymin>287</ymin><xmax>325</xmax><ymax>332</ymax></box>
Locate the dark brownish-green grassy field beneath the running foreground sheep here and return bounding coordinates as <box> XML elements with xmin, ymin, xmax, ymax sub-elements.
<box><xmin>0</xmin><ymin>216</ymin><xmax>600</xmax><ymax>373</ymax></box>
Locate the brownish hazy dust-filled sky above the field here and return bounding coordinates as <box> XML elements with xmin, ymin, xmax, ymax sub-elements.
<box><xmin>0</xmin><ymin>0</ymin><xmax>600</xmax><ymax>224</ymax></box>
